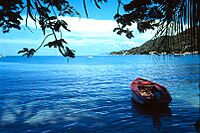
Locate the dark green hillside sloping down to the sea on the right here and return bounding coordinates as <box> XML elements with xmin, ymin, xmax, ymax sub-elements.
<box><xmin>110</xmin><ymin>27</ymin><xmax>200</xmax><ymax>55</ymax></box>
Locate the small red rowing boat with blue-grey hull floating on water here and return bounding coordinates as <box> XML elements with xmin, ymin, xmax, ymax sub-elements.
<box><xmin>130</xmin><ymin>78</ymin><xmax>172</xmax><ymax>104</ymax></box>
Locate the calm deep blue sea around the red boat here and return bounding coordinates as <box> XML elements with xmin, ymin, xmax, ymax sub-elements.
<box><xmin>0</xmin><ymin>55</ymin><xmax>200</xmax><ymax>133</ymax></box>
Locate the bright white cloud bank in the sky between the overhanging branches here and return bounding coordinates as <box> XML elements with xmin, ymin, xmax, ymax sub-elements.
<box><xmin>61</xmin><ymin>17</ymin><xmax>155</xmax><ymax>44</ymax></box>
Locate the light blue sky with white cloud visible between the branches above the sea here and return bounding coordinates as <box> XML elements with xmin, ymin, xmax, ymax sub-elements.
<box><xmin>0</xmin><ymin>0</ymin><xmax>155</xmax><ymax>56</ymax></box>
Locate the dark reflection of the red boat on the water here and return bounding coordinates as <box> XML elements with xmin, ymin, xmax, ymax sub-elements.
<box><xmin>131</xmin><ymin>99</ymin><xmax>171</xmax><ymax>128</ymax></box>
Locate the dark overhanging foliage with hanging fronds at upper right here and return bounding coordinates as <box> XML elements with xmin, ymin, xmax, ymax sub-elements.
<box><xmin>114</xmin><ymin>0</ymin><xmax>200</xmax><ymax>53</ymax></box>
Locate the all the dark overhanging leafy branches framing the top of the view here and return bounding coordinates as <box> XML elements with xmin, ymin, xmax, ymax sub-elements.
<box><xmin>0</xmin><ymin>0</ymin><xmax>200</xmax><ymax>57</ymax></box>
